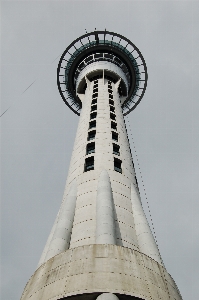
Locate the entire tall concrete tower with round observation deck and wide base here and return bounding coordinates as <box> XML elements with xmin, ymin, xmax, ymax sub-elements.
<box><xmin>21</xmin><ymin>31</ymin><xmax>182</xmax><ymax>300</ymax></box>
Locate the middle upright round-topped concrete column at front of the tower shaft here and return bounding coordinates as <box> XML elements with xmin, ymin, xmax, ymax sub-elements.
<box><xmin>96</xmin><ymin>170</ymin><xmax>116</xmax><ymax>245</ymax></box>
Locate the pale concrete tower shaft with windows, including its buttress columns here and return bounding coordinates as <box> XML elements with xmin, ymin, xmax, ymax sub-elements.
<box><xmin>39</xmin><ymin>78</ymin><xmax>161</xmax><ymax>265</ymax></box>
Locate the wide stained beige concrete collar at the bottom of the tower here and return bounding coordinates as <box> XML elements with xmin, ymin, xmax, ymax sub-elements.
<box><xmin>21</xmin><ymin>244</ymin><xmax>182</xmax><ymax>300</ymax></box>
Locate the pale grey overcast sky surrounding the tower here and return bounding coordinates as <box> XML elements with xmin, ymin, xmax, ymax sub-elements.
<box><xmin>1</xmin><ymin>0</ymin><xmax>199</xmax><ymax>300</ymax></box>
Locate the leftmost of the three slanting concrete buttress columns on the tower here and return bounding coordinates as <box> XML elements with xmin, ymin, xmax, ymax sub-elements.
<box><xmin>40</xmin><ymin>181</ymin><xmax>77</xmax><ymax>264</ymax></box>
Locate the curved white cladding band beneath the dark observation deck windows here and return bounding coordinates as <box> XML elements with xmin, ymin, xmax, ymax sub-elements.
<box><xmin>76</xmin><ymin>61</ymin><xmax>128</xmax><ymax>91</ymax></box>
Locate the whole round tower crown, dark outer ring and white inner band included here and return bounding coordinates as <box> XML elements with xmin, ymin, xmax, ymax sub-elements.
<box><xmin>57</xmin><ymin>30</ymin><xmax>148</xmax><ymax>115</ymax></box>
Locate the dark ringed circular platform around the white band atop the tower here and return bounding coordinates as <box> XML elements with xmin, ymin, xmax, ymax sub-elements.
<box><xmin>57</xmin><ymin>30</ymin><xmax>148</xmax><ymax>115</ymax></box>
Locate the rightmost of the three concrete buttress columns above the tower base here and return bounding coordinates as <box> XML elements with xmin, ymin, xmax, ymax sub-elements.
<box><xmin>131</xmin><ymin>184</ymin><xmax>163</xmax><ymax>265</ymax></box>
